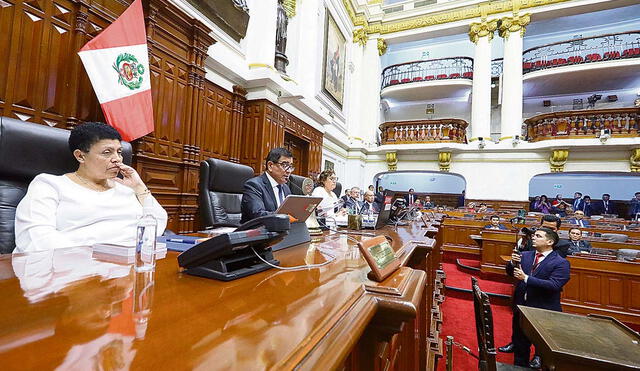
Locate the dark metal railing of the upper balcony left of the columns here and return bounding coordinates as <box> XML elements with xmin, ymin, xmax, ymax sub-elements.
<box><xmin>381</xmin><ymin>57</ymin><xmax>473</xmax><ymax>89</ymax></box>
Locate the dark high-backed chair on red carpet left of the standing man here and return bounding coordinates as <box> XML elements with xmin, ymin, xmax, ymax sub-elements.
<box><xmin>471</xmin><ymin>277</ymin><xmax>530</xmax><ymax>371</ymax></box>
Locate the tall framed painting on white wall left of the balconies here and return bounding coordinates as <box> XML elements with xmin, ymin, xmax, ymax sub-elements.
<box><xmin>322</xmin><ymin>9</ymin><xmax>346</xmax><ymax>109</ymax></box>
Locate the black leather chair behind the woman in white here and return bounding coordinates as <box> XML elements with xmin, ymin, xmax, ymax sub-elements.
<box><xmin>0</xmin><ymin>117</ymin><xmax>131</xmax><ymax>254</ymax></box>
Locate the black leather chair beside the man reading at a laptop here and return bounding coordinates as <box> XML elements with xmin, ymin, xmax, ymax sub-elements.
<box><xmin>198</xmin><ymin>158</ymin><xmax>253</xmax><ymax>228</ymax></box>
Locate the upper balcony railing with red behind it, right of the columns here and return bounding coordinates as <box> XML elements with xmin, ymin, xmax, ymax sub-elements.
<box><xmin>522</xmin><ymin>31</ymin><xmax>640</xmax><ymax>73</ymax></box>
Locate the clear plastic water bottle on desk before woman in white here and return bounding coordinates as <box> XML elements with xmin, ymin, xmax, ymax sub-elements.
<box><xmin>135</xmin><ymin>201</ymin><xmax>158</xmax><ymax>272</ymax></box>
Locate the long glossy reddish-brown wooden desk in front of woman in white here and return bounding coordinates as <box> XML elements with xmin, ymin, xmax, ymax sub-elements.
<box><xmin>0</xmin><ymin>224</ymin><xmax>437</xmax><ymax>370</ymax></box>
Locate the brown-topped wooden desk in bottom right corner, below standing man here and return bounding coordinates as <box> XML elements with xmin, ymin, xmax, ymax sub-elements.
<box><xmin>518</xmin><ymin>306</ymin><xmax>640</xmax><ymax>371</ymax></box>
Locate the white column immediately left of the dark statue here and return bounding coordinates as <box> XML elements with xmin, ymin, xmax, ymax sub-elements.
<box><xmin>245</xmin><ymin>0</ymin><xmax>278</xmax><ymax>68</ymax></box>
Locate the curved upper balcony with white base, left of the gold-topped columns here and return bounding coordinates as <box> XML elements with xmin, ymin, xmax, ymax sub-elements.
<box><xmin>380</xmin><ymin>57</ymin><xmax>473</xmax><ymax>101</ymax></box>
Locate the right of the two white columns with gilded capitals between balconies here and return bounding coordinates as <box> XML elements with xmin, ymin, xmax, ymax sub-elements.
<box><xmin>498</xmin><ymin>8</ymin><xmax>531</xmax><ymax>140</ymax></box>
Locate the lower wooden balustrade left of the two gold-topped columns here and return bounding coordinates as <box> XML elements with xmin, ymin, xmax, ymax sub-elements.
<box><xmin>380</xmin><ymin>119</ymin><xmax>469</xmax><ymax>144</ymax></box>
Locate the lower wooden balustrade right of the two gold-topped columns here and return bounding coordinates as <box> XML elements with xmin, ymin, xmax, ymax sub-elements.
<box><xmin>524</xmin><ymin>108</ymin><xmax>640</xmax><ymax>142</ymax></box>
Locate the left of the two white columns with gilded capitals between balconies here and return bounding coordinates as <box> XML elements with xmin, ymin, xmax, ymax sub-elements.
<box><xmin>469</xmin><ymin>18</ymin><xmax>498</xmax><ymax>138</ymax></box>
